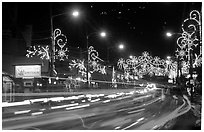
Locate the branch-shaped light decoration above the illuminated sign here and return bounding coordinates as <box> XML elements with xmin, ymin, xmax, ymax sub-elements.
<box><xmin>26</xmin><ymin>45</ymin><xmax>50</xmax><ymax>60</ymax></box>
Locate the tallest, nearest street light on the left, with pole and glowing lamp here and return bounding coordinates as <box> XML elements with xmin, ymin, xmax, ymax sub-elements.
<box><xmin>50</xmin><ymin>10</ymin><xmax>79</xmax><ymax>76</ymax></box>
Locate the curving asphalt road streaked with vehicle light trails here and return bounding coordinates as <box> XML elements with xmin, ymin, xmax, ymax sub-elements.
<box><xmin>2</xmin><ymin>87</ymin><xmax>191</xmax><ymax>130</ymax></box>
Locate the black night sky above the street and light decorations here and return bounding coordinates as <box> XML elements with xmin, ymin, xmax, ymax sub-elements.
<box><xmin>2</xmin><ymin>2</ymin><xmax>201</xmax><ymax>62</ymax></box>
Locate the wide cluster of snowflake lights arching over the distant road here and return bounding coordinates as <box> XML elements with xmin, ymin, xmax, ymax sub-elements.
<box><xmin>117</xmin><ymin>51</ymin><xmax>166</xmax><ymax>80</ymax></box>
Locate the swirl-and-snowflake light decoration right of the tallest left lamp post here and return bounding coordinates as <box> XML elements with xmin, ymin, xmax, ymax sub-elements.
<box><xmin>54</xmin><ymin>29</ymin><xmax>69</xmax><ymax>61</ymax></box>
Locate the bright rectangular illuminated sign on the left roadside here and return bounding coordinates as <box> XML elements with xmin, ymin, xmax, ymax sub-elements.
<box><xmin>15</xmin><ymin>65</ymin><xmax>41</xmax><ymax>78</ymax></box>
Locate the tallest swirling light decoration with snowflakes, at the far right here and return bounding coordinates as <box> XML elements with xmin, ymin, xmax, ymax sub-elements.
<box><xmin>176</xmin><ymin>10</ymin><xmax>202</xmax><ymax>72</ymax></box>
